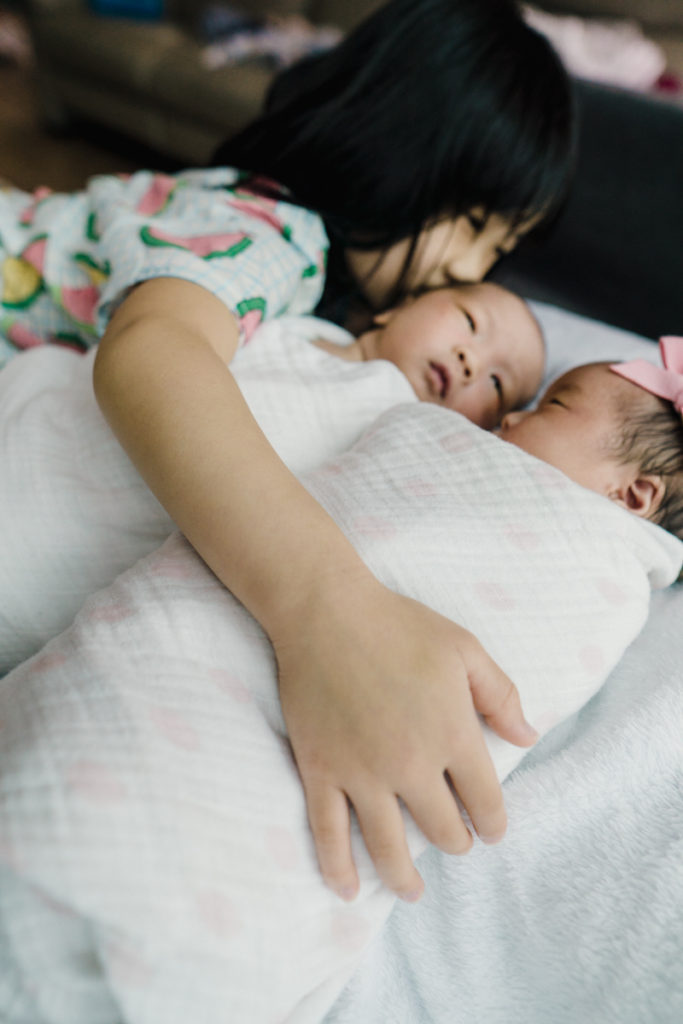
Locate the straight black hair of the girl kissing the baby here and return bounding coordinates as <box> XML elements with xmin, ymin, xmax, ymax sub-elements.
<box><xmin>214</xmin><ymin>0</ymin><xmax>573</xmax><ymax>315</ymax></box>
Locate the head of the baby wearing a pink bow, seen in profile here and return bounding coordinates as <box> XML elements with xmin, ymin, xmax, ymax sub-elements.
<box><xmin>498</xmin><ymin>337</ymin><xmax>683</xmax><ymax>540</ymax></box>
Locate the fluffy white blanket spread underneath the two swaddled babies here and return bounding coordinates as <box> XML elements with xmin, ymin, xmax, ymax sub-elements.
<box><xmin>325</xmin><ymin>304</ymin><xmax>683</xmax><ymax>1024</ymax></box>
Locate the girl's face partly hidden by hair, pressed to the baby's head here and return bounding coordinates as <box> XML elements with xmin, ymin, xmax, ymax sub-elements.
<box><xmin>346</xmin><ymin>208</ymin><xmax>532</xmax><ymax>309</ymax></box>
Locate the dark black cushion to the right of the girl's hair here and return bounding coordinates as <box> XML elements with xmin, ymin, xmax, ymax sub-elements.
<box><xmin>493</xmin><ymin>82</ymin><xmax>683</xmax><ymax>338</ymax></box>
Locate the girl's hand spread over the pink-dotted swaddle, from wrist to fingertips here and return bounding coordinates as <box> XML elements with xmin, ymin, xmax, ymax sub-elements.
<box><xmin>274</xmin><ymin>574</ymin><xmax>537</xmax><ymax>900</ymax></box>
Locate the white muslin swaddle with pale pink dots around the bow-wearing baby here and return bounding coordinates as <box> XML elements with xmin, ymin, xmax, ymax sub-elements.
<box><xmin>0</xmin><ymin>389</ymin><xmax>683</xmax><ymax>1024</ymax></box>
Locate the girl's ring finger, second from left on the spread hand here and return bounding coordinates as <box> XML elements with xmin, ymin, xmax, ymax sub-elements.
<box><xmin>353</xmin><ymin>786</ymin><xmax>424</xmax><ymax>902</ymax></box>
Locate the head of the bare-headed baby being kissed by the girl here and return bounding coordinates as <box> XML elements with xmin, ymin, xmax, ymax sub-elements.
<box><xmin>358</xmin><ymin>284</ymin><xmax>545</xmax><ymax>429</ymax></box>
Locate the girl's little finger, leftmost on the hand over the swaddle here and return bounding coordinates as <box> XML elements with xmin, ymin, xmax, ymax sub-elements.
<box><xmin>304</xmin><ymin>779</ymin><xmax>358</xmax><ymax>900</ymax></box>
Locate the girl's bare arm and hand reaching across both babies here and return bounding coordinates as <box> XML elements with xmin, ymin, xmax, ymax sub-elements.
<box><xmin>94</xmin><ymin>279</ymin><xmax>535</xmax><ymax>898</ymax></box>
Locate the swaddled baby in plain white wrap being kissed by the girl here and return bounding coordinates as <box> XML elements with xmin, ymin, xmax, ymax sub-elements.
<box><xmin>0</xmin><ymin>284</ymin><xmax>544</xmax><ymax>675</ymax></box>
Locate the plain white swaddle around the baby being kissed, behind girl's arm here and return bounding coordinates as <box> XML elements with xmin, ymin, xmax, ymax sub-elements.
<box><xmin>0</xmin><ymin>316</ymin><xmax>415</xmax><ymax>675</ymax></box>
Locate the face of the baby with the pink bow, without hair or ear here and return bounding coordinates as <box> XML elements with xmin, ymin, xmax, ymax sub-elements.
<box><xmin>499</xmin><ymin>362</ymin><xmax>634</xmax><ymax>497</ymax></box>
